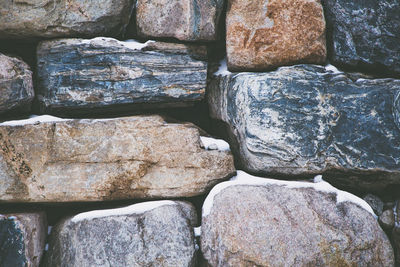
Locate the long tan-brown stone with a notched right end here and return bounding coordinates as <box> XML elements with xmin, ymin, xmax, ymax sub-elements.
<box><xmin>0</xmin><ymin>116</ymin><xmax>235</xmax><ymax>202</ymax></box>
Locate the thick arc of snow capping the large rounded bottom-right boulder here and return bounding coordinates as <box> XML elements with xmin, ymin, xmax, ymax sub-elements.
<box><xmin>202</xmin><ymin>171</ymin><xmax>377</xmax><ymax>218</ymax></box>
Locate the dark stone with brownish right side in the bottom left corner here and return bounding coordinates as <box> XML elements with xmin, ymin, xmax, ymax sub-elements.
<box><xmin>0</xmin><ymin>212</ymin><xmax>47</xmax><ymax>267</ymax></box>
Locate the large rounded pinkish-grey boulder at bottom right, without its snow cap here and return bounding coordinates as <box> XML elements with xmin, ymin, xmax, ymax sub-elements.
<box><xmin>201</xmin><ymin>185</ymin><xmax>394</xmax><ymax>266</ymax></box>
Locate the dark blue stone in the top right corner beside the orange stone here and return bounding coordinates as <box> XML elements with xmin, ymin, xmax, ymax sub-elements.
<box><xmin>322</xmin><ymin>0</ymin><xmax>400</xmax><ymax>74</ymax></box>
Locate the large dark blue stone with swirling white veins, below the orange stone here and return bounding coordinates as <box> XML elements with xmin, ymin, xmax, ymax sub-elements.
<box><xmin>208</xmin><ymin>65</ymin><xmax>400</xmax><ymax>192</ymax></box>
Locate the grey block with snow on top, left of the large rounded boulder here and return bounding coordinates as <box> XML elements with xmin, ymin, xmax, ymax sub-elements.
<box><xmin>45</xmin><ymin>201</ymin><xmax>197</xmax><ymax>267</ymax></box>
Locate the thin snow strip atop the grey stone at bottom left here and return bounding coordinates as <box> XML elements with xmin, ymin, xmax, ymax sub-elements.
<box><xmin>71</xmin><ymin>200</ymin><xmax>177</xmax><ymax>223</ymax></box>
